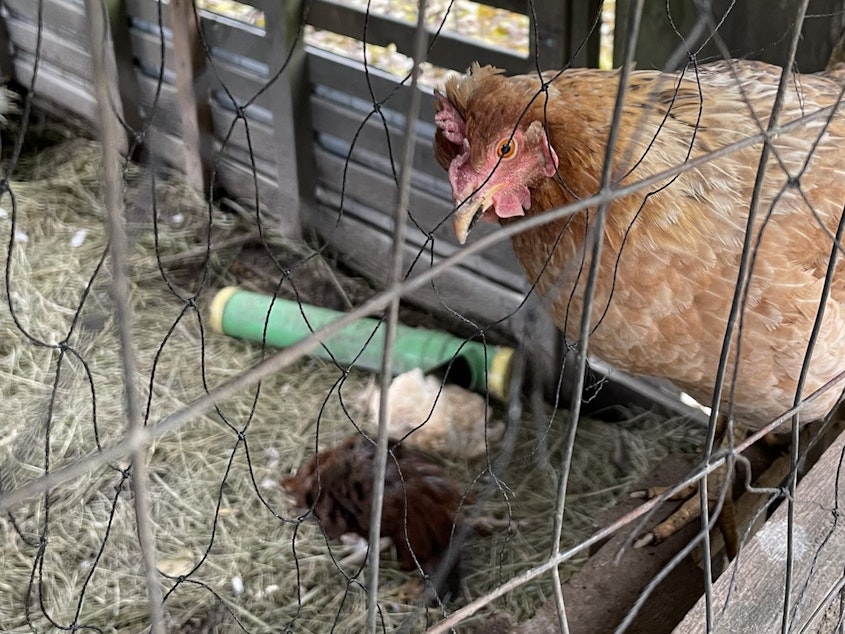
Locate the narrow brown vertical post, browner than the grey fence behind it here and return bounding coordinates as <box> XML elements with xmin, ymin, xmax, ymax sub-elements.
<box><xmin>170</xmin><ymin>0</ymin><xmax>214</xmax><ymax>193</ymax></box>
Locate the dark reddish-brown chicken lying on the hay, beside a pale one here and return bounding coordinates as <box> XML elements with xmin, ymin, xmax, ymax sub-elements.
<box><xmin>282</xmin><ymin>435</ymin><xmax>462</xmax><ymax>599</ymax></box>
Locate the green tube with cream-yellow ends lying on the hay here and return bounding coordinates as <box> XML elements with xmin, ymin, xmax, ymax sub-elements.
<box><xmin>209</xmin><ymin>286</ymin><xmax>513</xmax><ymax>400</ymax></box>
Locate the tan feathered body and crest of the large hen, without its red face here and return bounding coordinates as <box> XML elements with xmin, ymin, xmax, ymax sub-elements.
<box><xmin>436</xmin><ymin>61</ymin><xmax>845</xmax><ymax>427</ymax></box>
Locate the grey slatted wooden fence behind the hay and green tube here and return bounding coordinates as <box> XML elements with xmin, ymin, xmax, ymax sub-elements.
<box><xmin>2</xmin><ymin>0</ymin><xmax>598</xmax><ymax>338</ymax></box>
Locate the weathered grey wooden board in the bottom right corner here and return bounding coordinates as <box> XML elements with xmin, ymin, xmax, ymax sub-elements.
<box><xmin>675</xmin><ymin>428</ymin><xmax>845</xmax><ymax>634</ymax></box>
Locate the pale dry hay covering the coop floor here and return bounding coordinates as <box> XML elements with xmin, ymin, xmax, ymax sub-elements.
<box><xmin>0</xmin><ymin>140</ymin><xmax>695</xmax><ymax>632</ymax></box>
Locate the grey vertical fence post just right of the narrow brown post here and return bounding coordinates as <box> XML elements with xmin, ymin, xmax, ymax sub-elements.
<box><xmin>264</xmin><ymin>0</ymin><xmax>316</xmax><ymax>237</ymax></box>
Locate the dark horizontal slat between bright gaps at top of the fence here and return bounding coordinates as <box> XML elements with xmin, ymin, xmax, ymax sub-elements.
<box><xmin>308</xmin><ymin>0</ymin><xmax>531</xmax><ymax>72</ymax></box>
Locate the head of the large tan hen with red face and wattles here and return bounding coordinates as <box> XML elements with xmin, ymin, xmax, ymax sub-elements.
<box><xmin>435</xmin><ymin>64</ymin><xmax>558</xmax><ymax>244</ymax></box>
